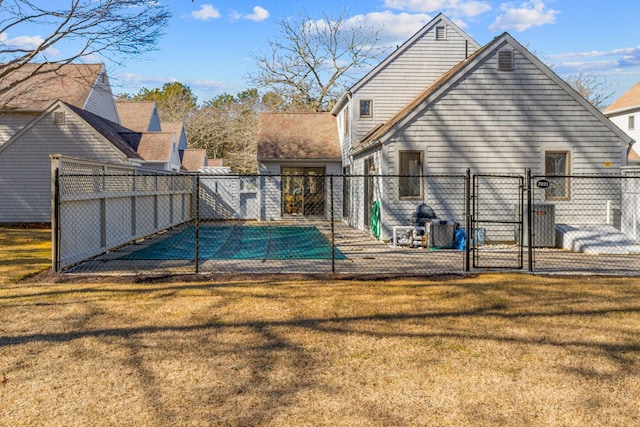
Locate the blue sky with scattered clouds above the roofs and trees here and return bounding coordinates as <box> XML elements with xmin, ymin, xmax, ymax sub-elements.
<box><xmin>0</xmin><ymin>0</ymin><xmax>640</xmax><ymax>106</ymax></box>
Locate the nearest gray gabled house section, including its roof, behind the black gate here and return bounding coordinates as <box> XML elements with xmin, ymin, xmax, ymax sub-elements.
<box><xmin>337</xmin><ymin>33</ymin><xmax>631</xmax><ymax>239</ymax></box>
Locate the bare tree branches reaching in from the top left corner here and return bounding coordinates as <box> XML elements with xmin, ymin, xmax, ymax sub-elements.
<box><xmin>0</xmin><ymin>0</ymin><xmax>171</xmax><ymax>107</ymax></box>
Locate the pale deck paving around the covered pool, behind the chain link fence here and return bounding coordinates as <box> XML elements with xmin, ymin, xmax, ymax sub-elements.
<box><xmin>69</xmin><ymin>219</ymin><xmax>640</xmax><ymax>276</ymax></box>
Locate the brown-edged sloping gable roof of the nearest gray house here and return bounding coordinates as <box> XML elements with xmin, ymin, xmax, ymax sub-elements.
<box><xmin>350</xmin><ymin>33</ymin><xmax>632</xmax><ymax>154</ymax></box>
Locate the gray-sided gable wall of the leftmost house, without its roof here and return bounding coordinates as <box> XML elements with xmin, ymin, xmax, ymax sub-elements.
<box><xmin>0</xmin><ymin>107</ymin><xmax>127</xmax><ymax>223</ymax></box>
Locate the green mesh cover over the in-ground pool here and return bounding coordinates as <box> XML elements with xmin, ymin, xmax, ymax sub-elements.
<box><xmin>120</xmin><ymin>225</ymin><xmax>346</xmax><ymax>260</ymax></box>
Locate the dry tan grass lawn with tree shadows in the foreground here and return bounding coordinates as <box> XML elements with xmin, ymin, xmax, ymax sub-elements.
<box><xmin>0</xmin><ymin>230</ymin><xmax>640</xmax><ymax>426</ymax></box>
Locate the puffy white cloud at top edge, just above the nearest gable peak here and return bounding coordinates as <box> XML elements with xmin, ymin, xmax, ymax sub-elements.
<box><xmin>489</xmin><ymin>0</ymin><xmax>559</xmax><ymax>31</ymax></box>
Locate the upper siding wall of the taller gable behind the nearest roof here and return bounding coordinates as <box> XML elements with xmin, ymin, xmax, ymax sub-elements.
<box><xmin>351</xmin><ymin>18</ymin><xmax>475</xmax><ymax>145</ymax></box>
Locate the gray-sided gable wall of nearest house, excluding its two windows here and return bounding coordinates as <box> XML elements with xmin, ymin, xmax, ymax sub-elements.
<box><xmin>364</xmin><ymin>39</ymin><xmax>625</xmax><ymax>241</ymax></box>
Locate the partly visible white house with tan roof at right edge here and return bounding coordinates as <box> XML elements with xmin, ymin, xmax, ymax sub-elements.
<box><xmin>604</xmin><ymin>82</ymin><xmax>640</xmax><ymax>165</ymax></box>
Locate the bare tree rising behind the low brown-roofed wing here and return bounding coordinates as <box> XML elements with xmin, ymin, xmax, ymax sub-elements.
<box><xmin>248</xmin><ymin>13</ymin><xmax>381</xmax><ymax>111</ymax></box>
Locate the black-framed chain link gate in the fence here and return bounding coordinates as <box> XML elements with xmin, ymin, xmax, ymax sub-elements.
<box><xmin>469</xmin><ymin>175</ymin><xmax>526</xmax><ymax>269</ymax></box>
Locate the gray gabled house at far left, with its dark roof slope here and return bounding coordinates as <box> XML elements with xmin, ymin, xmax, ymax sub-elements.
<box><xmin>0</xmin><ymin>101</ymin><xmax>144</xmax><ymax>223</ymax></box>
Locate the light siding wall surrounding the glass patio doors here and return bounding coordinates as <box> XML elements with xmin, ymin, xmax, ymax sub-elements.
<box><xmin>258</xmin><ymin>160</ymin><xmax>342</xmax><ymax>221</ymax></box>
